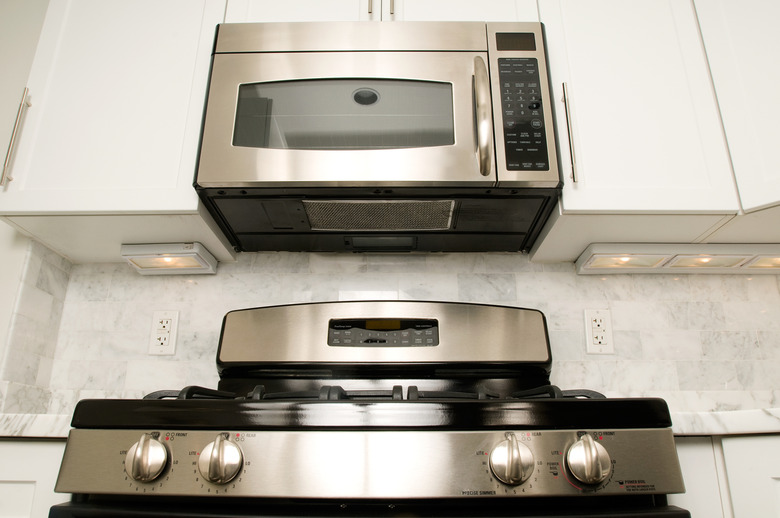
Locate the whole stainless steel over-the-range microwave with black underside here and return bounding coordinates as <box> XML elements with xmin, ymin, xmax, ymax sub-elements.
<box><xmin>195</xmin><ymin>22</ymin><xmax>561</xmax><ymax>252</ymax></box>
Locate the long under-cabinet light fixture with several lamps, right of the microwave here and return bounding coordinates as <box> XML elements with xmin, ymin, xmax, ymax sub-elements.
<box><xmin>575</xmin><ymin>243</ymin><xmax>780</xmax><ymax>275</ymax></box>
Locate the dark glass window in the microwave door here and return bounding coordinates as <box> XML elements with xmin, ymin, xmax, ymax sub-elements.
<box><xmin>233</xmin><ymin>78</ymin><xmax>455</xmax><ymax>150</ymax></box>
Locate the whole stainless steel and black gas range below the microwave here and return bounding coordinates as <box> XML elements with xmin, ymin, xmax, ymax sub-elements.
<box><xmin>50</xmin><ymin>301</ymin><xmax>690</xmax><ymax>517</ymax></box>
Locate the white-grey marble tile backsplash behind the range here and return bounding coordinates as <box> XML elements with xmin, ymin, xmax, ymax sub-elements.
<box><xmin>0</xmin><ymin>253</ymin><xmax>780</xmax><ymax>414</ymax></box>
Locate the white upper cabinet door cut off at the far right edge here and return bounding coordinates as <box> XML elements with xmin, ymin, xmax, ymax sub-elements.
<box><xmin>695</xmin><ymin>0</ymin><xmax>780</xmax><ymax>212</ymax></box>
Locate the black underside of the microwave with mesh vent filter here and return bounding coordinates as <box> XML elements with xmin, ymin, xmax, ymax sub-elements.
<box><xmin>198</xmin><ymin>188</ymin><xmax>559</xmax><ymax>252</ymax></box>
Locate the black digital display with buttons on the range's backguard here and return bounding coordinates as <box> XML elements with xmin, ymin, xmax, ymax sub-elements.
<box><xmin>328</xmin><ymin>318</ymin><xmax>439</xmax><ymax>347</ymax></box>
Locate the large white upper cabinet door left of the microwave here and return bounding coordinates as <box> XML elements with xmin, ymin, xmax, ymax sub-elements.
<box><xmin>0</xmin><ymin>0</ymin><xmax>224</xmax><ymax>214</ymax></box>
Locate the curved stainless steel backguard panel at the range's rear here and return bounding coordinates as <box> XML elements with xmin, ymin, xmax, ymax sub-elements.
<box><xmin>217</xmin><ymin>300</ymin><xmax>552</xmax><ymax>371</ymax></box>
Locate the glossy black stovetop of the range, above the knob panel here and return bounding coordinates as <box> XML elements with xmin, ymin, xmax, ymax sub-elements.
<box><xmin>72</xmin><ymin>386</ymin><xmax>671</xmax><ymax>430</ymax></box>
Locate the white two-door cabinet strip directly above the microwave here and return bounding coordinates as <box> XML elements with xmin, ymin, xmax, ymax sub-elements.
<box><xmin>225</xmin><ymin>0</ymin><xmax>539</xmax><ymax>23</ymax></box>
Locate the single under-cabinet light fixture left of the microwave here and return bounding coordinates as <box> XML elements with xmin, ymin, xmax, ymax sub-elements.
<box><xmin>121</xmin><ymin>243</ymin><xmax>217</xmax><ymax>275</ymax></box>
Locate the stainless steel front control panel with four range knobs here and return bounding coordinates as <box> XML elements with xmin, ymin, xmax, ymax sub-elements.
<box><xmin>56</xmin><ymin>428</ymin><xmax>684</xmax><ymax>499</ymax></box>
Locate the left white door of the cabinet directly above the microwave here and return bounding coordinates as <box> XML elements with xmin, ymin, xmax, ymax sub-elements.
<box><xmin>225</xmin><ymin>0</ymin><xmax>382</xmax><ymax>23</ymax></box>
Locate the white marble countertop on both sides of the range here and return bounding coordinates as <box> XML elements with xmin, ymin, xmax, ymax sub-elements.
<box><xmin>0</xmin><ymin>408</ymin><xmax>780</xmax><ymax>438</ymax></box>
